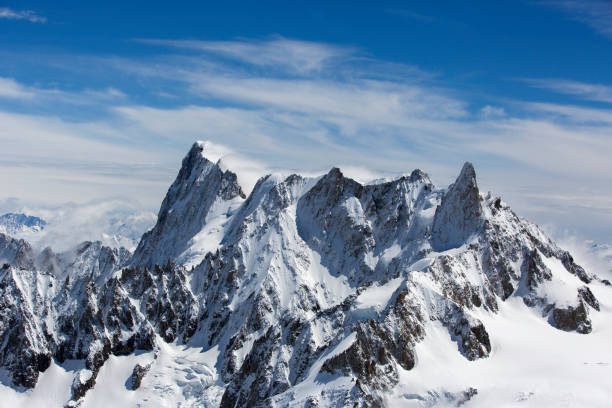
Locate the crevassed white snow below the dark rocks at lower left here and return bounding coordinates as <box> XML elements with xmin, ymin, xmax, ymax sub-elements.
<box><xmin>0</xmin><ymin>341</ymin><xmax>223</xmax><ymax>408</ymax></box>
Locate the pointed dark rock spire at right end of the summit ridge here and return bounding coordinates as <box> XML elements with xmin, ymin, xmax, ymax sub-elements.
<box><xmin>432</xmin><ymin>162</ymin><xmax>484</xmax><ymax>251</ymax></box>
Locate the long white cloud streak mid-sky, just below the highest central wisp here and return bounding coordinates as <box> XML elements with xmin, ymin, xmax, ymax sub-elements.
<box><xmin>188</xmin><ymin>74</ymin><xmax>466</xmax><ymax>125</ymax></box>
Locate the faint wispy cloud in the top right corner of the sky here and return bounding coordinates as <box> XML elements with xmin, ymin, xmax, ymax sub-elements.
<box><xmin>539</xmin><ymin>0</ymin><xmax>612</xmax><ymax>39</ymax></box>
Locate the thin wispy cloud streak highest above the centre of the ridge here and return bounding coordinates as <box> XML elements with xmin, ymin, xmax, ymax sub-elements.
<box><xmin>135</xmin><ymin>37</ymin><xmax>430</xmax><ymax>81</ymax></box>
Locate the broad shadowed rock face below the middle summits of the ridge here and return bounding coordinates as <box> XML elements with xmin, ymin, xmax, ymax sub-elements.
<box><xmin>297</xmin><ymin>168</ymin><xmax>433</xmax><ymax>284</ymax></box>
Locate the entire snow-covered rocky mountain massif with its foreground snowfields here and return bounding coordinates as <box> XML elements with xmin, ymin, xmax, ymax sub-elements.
<box><xmin>0</xmin><ymin>143</ymin><xmax>612</xmax><ymax>407</ymax></box>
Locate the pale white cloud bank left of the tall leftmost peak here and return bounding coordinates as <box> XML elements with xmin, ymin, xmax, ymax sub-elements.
<box><xmin>0</xmin><ymin>112</ymin><xmax>177</xmax><ymax>204</ymax></box>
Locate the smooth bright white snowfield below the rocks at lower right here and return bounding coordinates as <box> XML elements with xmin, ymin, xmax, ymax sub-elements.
<box><xmin>386</xmin><ymin>284</ymin><xmax>612</xmax><ymax>408</ymax></box>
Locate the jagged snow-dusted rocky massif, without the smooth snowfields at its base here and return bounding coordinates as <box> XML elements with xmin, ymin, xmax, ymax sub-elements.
<box><xmin>0</xmin><ymin>144</ymin><xmax>599</xmax><ymax>407</ymax></box>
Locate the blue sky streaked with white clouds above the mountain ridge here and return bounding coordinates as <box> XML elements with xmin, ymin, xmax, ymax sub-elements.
<box><xmin>0</xmin><ymin>0</ymin><xmax>612</xmax><ymax>241</ymax></box>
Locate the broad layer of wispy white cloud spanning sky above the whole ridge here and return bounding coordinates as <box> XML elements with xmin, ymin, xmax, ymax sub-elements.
<box><xmin>0</xmin><ymin>38</ymin><xmax>612</xmax><ymax>241</ymax></box>
